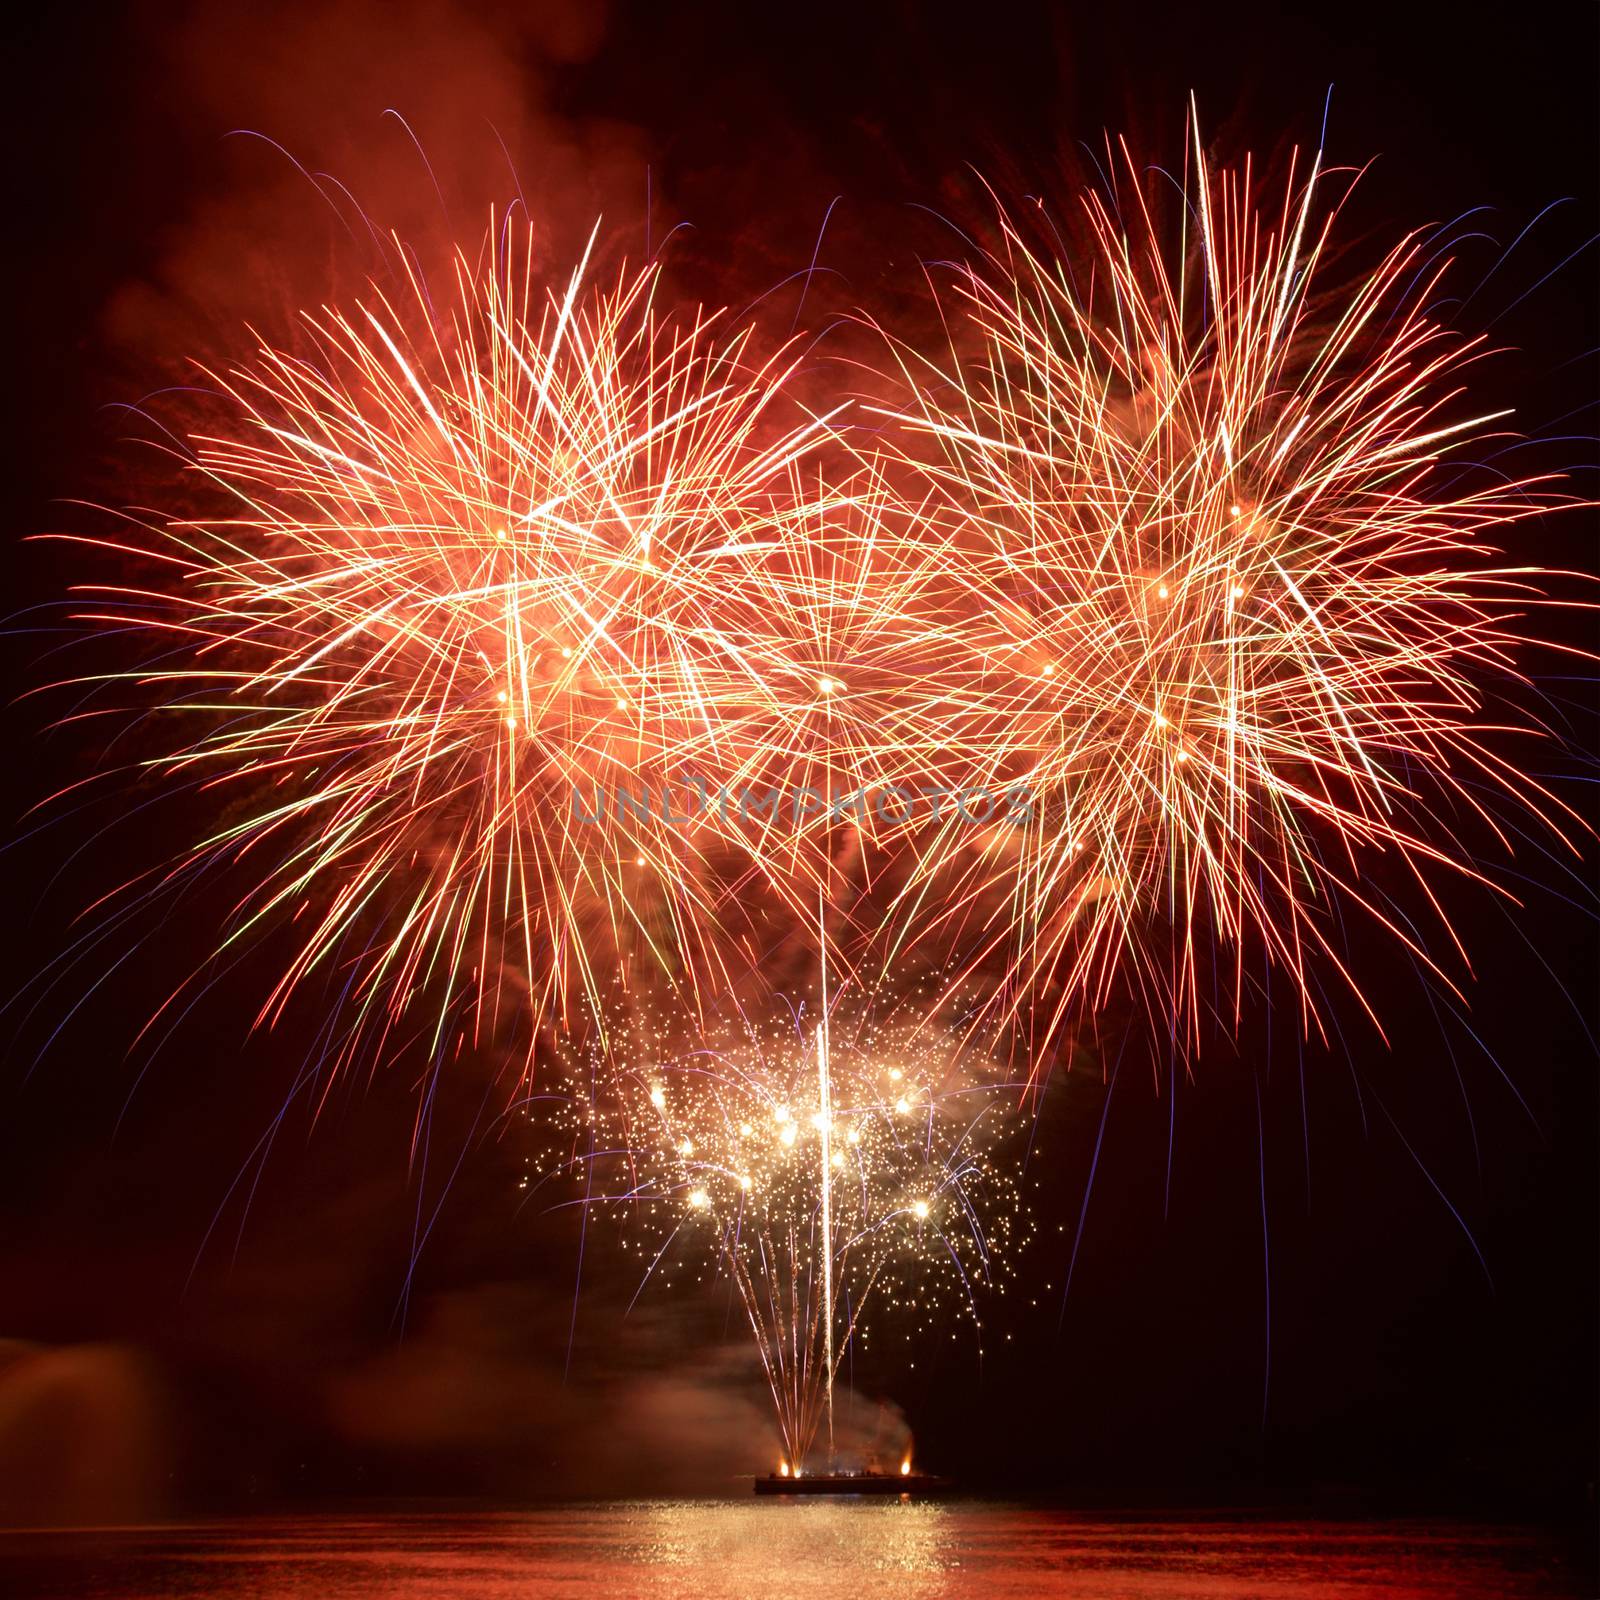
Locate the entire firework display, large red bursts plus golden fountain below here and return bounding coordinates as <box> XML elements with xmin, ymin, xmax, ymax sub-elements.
<box><xmin>28</xmin><ymin>106</ymin><xmax>1578</xmax><ymax>1470</ymax></box>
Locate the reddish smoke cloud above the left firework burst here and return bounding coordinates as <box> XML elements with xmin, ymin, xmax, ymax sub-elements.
<box><xmin>107</xmin><ymin>0</ymin><xmax>646</xmax><ymax>381</ymax></box>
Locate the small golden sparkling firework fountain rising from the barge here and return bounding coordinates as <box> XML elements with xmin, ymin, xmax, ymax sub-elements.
<box><xmin>533</xmin><ymin>1018</ymin><xmax>1032</xmax><ymax>1470</ymax></box>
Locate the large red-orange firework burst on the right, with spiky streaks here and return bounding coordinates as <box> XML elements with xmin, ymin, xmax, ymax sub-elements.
<box><xmin>874</xmin><ymin>116</ymin><xmax>1576</xmax><ymax>1046</ymax></box>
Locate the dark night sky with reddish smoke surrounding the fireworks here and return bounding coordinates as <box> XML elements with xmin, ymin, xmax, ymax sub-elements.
<box><xmin>0</xmin><ymin>3</ymin><xmax>1597</xmax><ymax>1522</ymax></box>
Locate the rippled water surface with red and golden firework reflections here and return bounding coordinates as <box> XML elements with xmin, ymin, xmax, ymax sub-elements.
<box><xmin>0</xmin><ymin>1499</ymin><xmax>1581</xmax><ymax>1600</ymax></box>
